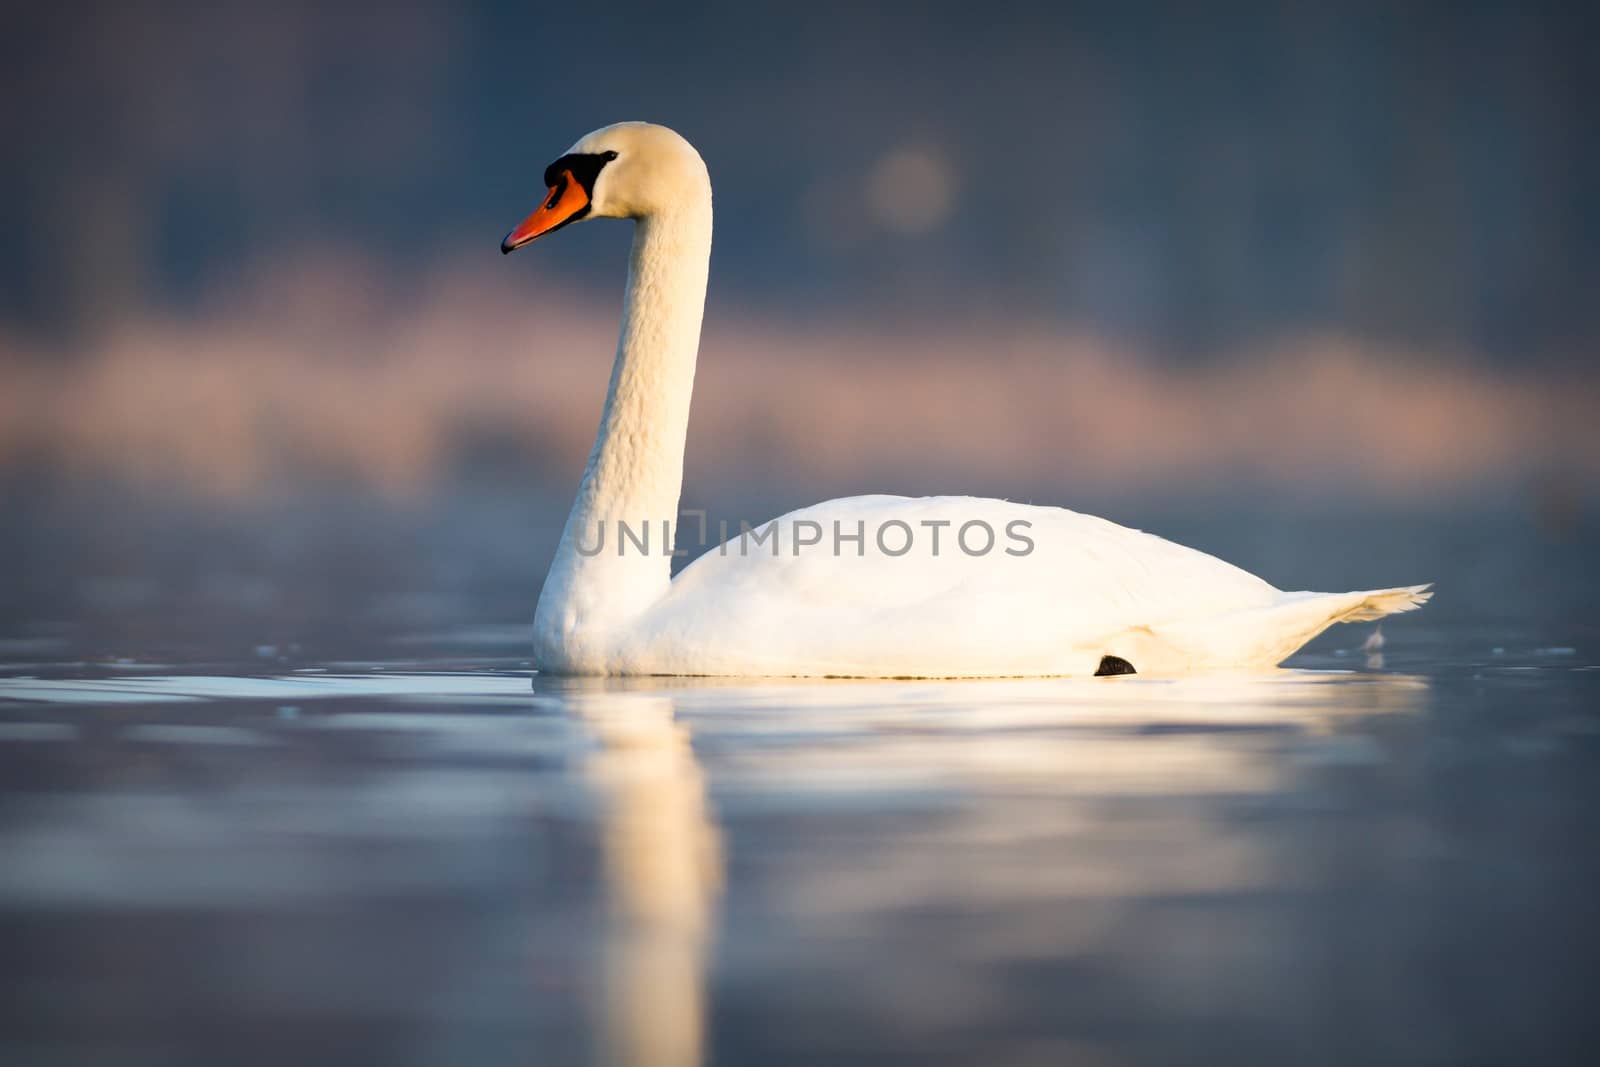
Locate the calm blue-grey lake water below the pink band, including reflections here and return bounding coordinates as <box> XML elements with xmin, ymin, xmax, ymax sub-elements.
<box><xmin>0</xmin><ymin>495</ymin><xmax>1600</xmax><ymax>1065</ymax></box>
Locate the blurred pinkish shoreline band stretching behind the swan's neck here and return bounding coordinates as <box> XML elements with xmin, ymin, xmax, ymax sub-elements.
<box><xmin>0</xmin><ymin>258</ymin><xmax>1600</xmax><ymax>501</ymax></box>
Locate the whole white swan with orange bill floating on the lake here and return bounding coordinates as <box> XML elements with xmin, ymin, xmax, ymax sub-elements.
<box><xmin>501</xmin><ymin>122</ymin><xmax>1432</xmax><ymax>678</ymax></box>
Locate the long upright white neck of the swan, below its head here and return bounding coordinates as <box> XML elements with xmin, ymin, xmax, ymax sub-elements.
<box><xmin>534</xmin><ymin>195</ymin><xmax>710</xmax><ymax>669</ymax></box>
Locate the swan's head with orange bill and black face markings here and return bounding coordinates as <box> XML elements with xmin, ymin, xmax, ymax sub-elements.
<box><xmin>501</xmin><ymin>122</ymin><xmax>710</xmax><ymax>253</ymax></box>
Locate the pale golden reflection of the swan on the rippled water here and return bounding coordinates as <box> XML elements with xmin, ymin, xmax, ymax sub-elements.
<box><xmin>538</xmin><ymin>670</ymin><xmax>1429</xmax><ymax>1067</ymax></box>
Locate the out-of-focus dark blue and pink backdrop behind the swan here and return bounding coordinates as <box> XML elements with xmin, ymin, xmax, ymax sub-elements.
<box><xmin>0</xmin><ymin>2</ymin><xmax>1600</xmax><ymax>653</ymax></box>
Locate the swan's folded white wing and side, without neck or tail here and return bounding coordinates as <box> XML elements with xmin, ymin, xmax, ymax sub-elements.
<box><xmin>624</xmin><ymin>496</ymin><xmax>1278</xmax><ymax>677</ymax></box>
